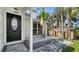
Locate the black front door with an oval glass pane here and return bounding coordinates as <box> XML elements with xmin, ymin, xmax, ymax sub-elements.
<box><xmin>6</xmin><ymin>13</ymin><xmax>21</xmax><ymax>42</ymax></box>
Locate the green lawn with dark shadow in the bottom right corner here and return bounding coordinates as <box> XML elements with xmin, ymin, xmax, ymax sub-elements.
<box><xmin>62</xmin><ymin>39</ymin><xmax>79</xmax><ymax>52</ymax></box>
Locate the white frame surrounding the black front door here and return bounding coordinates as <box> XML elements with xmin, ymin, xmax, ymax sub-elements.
<box><xmin>4</xmin><ymin>11</ymin><xmax>23</xmax><ymax>45</ymax></box>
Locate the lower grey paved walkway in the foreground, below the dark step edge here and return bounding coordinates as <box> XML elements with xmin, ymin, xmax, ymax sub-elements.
<box><xmin>34</xmin><ymin>42</ymin><xmax>67</xmax><ymax>52</ymax></box>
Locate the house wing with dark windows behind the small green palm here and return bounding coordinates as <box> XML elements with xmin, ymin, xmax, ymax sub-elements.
<box><xmin>32</xmin><ymin>10</ymin><xmax>47</xmax><ymax>35</ymax></box>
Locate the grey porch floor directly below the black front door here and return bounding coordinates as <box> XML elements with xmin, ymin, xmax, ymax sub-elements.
<box><xmin>2</xmin><ymin>40</ymin><xmax>29</xmax><ymax>52</ymax></box>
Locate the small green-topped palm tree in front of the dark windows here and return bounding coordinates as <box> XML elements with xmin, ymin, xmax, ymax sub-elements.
<box><xmin>38</xmin><ymin>8</ymin><xmax>48</xmax><ymax>37</ymax></box>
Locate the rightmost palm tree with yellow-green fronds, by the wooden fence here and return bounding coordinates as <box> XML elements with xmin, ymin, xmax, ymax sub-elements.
<box><xmin>65</xmin><ymin>7</ymin><xmax>79</xmax><ymax>40</ymax></box>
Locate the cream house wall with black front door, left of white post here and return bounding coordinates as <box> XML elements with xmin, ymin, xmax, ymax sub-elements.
<box><xmin>0</xmin><ymin>7</ymin><xmax>31</xmax><ymax>51</ymax></box>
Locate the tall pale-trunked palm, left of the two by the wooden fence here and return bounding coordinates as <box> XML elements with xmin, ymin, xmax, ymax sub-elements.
<box><xmin>55</xmin><ymin>7</ymin><xmax>64</xmax><ymax>39</ymax></box>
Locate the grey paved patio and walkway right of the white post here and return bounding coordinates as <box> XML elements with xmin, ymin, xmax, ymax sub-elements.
<box><xmin>33</xmin><ymin>36</ymin><xmax>68</xmax><ymax>52</ymax></box>
